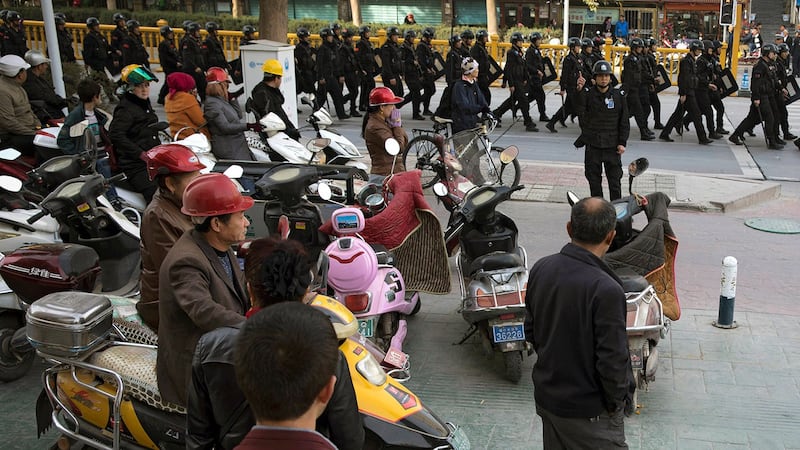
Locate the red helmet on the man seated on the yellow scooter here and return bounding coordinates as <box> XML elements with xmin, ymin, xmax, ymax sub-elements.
<box><xmin>181</xmin><ymin>173</ymin><xmax>255</xmax><ymax>217</ymax></box>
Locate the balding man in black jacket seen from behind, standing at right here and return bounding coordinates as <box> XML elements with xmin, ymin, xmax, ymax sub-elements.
<box><xmin>525</xmin><ymin>197</ymin><xmax>635</xmax><ymax>448</ymax></box>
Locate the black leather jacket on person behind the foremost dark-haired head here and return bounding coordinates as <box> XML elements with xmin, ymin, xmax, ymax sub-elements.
<box><xmin>186</xmin><ymin>327</ymin><xmax>364</xmax><ymax>450</ymax></box>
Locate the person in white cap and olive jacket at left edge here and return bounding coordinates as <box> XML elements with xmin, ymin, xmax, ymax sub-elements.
<box><xmin>0</xmin><ymin>55</ymin><xmax>41</xmax><ymax>162</ymax></box>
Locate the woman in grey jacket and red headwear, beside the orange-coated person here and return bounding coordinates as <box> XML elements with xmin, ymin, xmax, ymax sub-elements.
<box><xmin>203</xmin><ymin>67</ymin><xmax>253</xmax><ymax>161</ymax></box>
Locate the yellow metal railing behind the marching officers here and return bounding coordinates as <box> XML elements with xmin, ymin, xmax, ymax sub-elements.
<box><xmin>25</xmin><ymin>20</ymin><xmax>735</xmax><ymax>85</ymax></box>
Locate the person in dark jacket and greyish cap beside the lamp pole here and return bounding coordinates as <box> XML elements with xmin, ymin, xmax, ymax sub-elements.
<box><xmin>22</xmin><ymin>50</ymin><xmax>67</xmax><ymax>123</ymax></box>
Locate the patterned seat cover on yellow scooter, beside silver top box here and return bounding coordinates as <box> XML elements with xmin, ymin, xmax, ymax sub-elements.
<box><xmin>89</xmin><ymin>345</ymin><xmax>186</xmax><ymax>414</ymax></box>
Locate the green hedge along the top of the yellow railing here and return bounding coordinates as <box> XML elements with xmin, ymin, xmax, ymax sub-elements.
<box><xmin>17</xmin><ymin>4</ymin><xmax>561</xmax><ymax>41</ymax></box>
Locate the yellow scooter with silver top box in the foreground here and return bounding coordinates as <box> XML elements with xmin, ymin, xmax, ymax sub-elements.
<box><xmin>28</xmin><ymin>292</ymin><xmax>470</xmax><ymax>450</ymax></box>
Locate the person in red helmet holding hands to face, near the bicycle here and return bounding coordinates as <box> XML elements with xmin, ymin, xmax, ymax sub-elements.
<box><xmin>361</xmin><ymin>86</ymin><xmax>408</xmax><ymax>178</ymax></box>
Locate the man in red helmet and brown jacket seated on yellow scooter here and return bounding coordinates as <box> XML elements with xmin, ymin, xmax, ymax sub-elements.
<box><xmin>156</xmin><ymin>173</ymin><xmax>253</xmax><ymax>405</ymax></box>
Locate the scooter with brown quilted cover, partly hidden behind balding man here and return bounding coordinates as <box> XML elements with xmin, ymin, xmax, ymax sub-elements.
<box><xmin>567</xmin><ymin>158</ymin><xmax>680</xmax><ymax>407</ymax></box>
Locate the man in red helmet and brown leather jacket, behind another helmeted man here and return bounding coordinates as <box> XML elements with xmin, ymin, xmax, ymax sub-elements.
<box><xmin>136</xmin><ymin>144</ymin><xmax>205</xmax><ymax>331</ymax></box>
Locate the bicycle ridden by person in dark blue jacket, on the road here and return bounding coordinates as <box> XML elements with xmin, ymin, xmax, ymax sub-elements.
<box><xmin>403</xmin><ymin>115</ymin><xmax>521</xmax><ymax>189</ymax></box>
